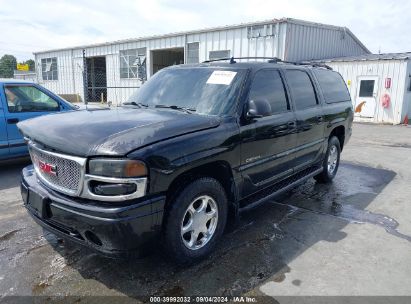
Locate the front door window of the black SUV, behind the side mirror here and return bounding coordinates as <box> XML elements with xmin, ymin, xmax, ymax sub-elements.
<box><xmin>249</xmin><ymin>70</ymin><xmax>289</xmax><ymax>114</ymax></box>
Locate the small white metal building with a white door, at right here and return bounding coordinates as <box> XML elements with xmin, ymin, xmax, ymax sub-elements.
<box><xmin>321</xmin><ymin>53</ymin><xmax>411</xmax><ymax>124</ymax></box>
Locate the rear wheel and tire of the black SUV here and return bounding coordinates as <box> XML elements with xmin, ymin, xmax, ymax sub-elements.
<box><xmin>314</xmin><ymin>136</ymin><xmax>341</xmax><ymax>183</ymax></box>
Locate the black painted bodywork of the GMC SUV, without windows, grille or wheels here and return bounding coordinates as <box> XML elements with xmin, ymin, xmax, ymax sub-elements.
<box><xmin>19</xmin><ymin>62</ymin><xmax>353</xmax><ymax>254</ymax></box>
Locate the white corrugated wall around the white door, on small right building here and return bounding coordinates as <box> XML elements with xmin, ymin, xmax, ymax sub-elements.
<box><xmin>327</xmin><ymin>60</ymin><xmax>411</xmax><ymax>124</ymax></box>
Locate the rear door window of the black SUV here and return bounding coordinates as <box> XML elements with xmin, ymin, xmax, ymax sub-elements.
<box><xmin>285</xmin><ymin>70</ymin><xmax>317</xmax><ymax>110</ymax></box>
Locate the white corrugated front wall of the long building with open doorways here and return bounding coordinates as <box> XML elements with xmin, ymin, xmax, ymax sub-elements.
<box><xmin>36</xmin><ymin>23</ymin><xmax>286</xmax><ymax>104</ymax></box>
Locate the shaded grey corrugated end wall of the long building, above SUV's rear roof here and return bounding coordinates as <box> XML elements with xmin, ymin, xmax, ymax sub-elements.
<box><xmin>285</xmin><ymin>23</ymin><xmax>367</xmax><ymax>61</ymax></box>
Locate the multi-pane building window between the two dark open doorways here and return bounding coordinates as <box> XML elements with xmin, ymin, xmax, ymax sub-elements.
<box><xmin>120</xmin><ymin>48</ymin><xmax>147</xmax><ymax>80</ymax></box>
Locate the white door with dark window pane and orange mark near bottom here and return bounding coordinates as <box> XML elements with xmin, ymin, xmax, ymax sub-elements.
<box><xmin>354</xmin><ymin>76</ymin><xmax>378</xmax><ymax>118</ymax></box>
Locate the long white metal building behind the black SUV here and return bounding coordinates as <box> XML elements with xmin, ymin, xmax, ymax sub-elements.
<box><xmin>35</xmin><ymin>18</ymin><xmax>369</xmax><ymax>104</ymax></box>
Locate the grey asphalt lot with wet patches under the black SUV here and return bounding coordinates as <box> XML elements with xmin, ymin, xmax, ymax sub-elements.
<box><xmin>0</xmin><ymin>124</ymin><xmax>411</xmax><ymax>302</ymax></box>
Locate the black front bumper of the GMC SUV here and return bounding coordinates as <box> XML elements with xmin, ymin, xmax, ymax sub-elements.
<box><xmin>21</xmin><ymin>166</ymin><xmax>165</xmax><ymax>257</ymax></box>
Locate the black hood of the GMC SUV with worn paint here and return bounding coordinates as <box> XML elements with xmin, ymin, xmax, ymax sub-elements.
<box><xmin>17</xmin><ymin>108</ymin><xmax>220</xmax><ymax>157</ymax></box>
